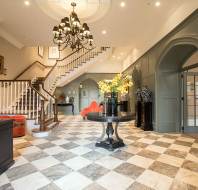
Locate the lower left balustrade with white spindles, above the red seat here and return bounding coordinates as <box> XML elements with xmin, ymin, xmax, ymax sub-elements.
<box><xmin>0</xmin><ymin>80</ymin><xmax>48</xmax><ymax>124</ymax></box>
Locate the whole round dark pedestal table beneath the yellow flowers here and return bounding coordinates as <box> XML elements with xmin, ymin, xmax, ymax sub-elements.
<box><xmin>87</xmin><ymin>113</ymin><xmax>134</xmax><ymax>150</ymax></box>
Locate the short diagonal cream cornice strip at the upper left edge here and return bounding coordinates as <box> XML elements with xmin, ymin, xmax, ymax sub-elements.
<box><xmin>0</xmin><ymin>28</ymin><xmax>24</xmax><ymax>49</ymax></box>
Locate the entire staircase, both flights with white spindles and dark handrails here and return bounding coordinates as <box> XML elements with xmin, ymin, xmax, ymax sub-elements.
<box><xmin>0</xmin><ymin>47</ymin><xmax>111</xmax><ymax>131</ymax></box>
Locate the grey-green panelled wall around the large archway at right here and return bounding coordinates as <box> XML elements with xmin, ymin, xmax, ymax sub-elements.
<box><xmin>124</xmin><ymin>11</ymin><xmax>198</xmax><ymax>132</ymax></box>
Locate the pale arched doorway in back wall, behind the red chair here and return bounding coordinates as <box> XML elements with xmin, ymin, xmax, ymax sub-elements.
<box><xmin>79</xmin><ymin>79</ymin><xmax>99</xmax><ymax>111</ymax></box>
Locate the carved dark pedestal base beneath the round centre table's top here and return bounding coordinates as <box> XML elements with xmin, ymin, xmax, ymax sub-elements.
<box><xmin>96</xmin><ymin>122</ymin><xmax>125</xmax><ymax>151</ymax></box>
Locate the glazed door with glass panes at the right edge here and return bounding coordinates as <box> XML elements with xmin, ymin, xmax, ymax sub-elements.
<box><xmin>183</xmin><ymin>72</ymin><xmax>198</xmax><ymax>133</ymax></box>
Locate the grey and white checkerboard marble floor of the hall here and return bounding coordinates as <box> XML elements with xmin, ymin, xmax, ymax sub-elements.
<box><xmin>0</xmin><ymin>116</ymin><xmax>198</xmax><ymax>190</ymax></box>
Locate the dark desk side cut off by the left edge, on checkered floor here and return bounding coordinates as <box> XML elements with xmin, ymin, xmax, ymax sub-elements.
<box><xmin>0</xmin><ymin>120</ymin><xmax>14</xmax><ymax>174</ymax></box>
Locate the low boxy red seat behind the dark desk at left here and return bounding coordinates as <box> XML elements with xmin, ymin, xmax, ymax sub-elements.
<box><xmin>0</xmin><ymin>115</ymin><xmax>26</xmax><ymax>137</ymax></box>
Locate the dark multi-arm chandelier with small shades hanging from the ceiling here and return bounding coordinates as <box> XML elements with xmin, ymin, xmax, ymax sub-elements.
<box><xmin>53</xmin><ymin>2</ymin><xmax>93</xmax><ymax>51</ymax></box>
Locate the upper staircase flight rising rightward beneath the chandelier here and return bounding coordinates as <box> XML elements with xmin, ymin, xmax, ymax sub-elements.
<box><xmin>44</xmin><ymin>47</ymin><xmax>111</xmax><ymax>94</ymax></box>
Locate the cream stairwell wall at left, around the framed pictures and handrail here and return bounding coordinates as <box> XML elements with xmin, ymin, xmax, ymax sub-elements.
<box><xmin>0</xmin><ymin>37</ymin><xmax>71</xmax><ymax>80</ymax></box>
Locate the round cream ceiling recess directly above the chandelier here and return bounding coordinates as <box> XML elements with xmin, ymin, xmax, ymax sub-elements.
<box><xmin>36</xmin><ymin>0</ymin><xmax>111</xmax><ymax>23</ymax></box>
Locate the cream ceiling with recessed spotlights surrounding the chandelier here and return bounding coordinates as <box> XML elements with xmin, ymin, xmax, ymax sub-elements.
<box><xmin>0</xmin><ymin>0</ymin><xmax>198</xmax><ymax>57</ymax></box>
